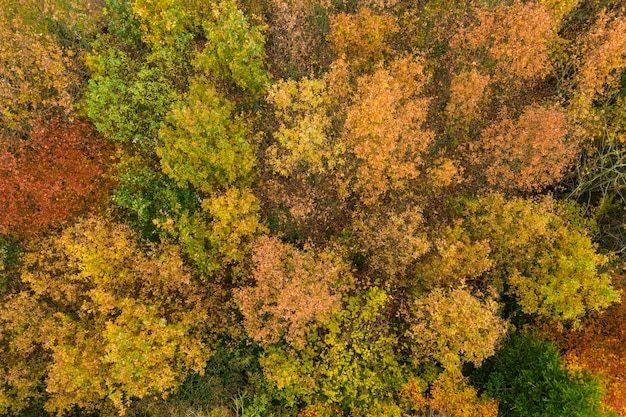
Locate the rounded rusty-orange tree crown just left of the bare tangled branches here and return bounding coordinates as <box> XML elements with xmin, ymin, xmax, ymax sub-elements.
<box><xmin>469</xmin><ymin>105</ymin><xmax>577</xmax><ymax>191</ymax></box>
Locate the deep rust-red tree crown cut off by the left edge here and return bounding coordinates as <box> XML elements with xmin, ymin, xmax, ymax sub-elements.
<box><xmin>0</xmin><ymin>119</ymin><xmax>112</xmax><ymax>233</ymax></box>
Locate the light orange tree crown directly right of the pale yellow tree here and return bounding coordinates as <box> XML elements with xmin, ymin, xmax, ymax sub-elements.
<box><xmin>343</xmin><ymin>59</ymin><xmax>434</xmax><ymax>203</ymax></box>
